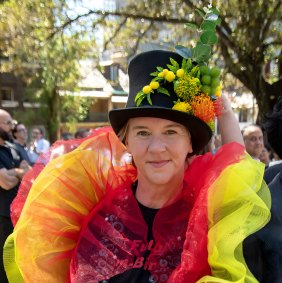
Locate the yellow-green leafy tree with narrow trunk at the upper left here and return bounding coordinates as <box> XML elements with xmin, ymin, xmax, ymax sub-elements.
<box><xmin>0</xmin><ymin>0</ymin><xmax>95</xmax><ymax>142</ymax></box>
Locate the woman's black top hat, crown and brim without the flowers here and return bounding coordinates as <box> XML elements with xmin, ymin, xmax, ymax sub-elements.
<box><xmin>109</xmin><ymin>50</ymin><xmax>212</xmax><ymax>154</ymax></box>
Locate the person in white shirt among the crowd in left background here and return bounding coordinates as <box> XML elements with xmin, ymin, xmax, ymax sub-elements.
<box><xmin>28</xmin><ymin>128</ymin><xmax>50</xmax><ymax>164</ymax></box>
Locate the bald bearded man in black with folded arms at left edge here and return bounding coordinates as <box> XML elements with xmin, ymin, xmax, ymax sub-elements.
<box><xmin>0</xmin><ymin>109</ymin><xmax>30</xmax><ymax>283</ymax></box>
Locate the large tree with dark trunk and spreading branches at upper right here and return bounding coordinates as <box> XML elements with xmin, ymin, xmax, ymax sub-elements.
<box><xmin>51</xmin><ymin>0</ymin><xmax>282</xmax><ymax>122</ymax></box>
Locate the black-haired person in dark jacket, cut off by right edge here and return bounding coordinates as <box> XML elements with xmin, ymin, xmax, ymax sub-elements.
<box><xmin>251</xmin><ymin>96</ymin><xmax>282</xmax><ymax>283</ymax></box>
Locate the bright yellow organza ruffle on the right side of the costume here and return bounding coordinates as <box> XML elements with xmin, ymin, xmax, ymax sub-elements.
<box><xmin>198</xmin><ymin>154</ymin><xmax>271</xmax><ymax>283</ymax></box>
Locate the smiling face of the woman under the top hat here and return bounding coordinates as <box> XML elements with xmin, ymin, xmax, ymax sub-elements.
<box><xmin>126</xmin><ymin>117</ymin><xmax>192</xmax><ymax>185</ymax></box>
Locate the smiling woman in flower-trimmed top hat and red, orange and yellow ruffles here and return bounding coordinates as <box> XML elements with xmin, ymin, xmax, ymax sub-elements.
<box><xmin>3</xmin><ymin>51</ymin><xmax>269</xmax><ymax>283</ymax></box>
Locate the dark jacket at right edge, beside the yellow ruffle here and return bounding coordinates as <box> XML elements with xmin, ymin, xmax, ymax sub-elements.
<box><xmin>243</xmin><ymin>168</ymin><xmax>282</xmax><ymax>283</ymax></box>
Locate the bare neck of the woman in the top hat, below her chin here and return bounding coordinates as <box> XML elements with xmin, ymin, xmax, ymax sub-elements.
<box><xmin>135</xmin><ymin>179</ymin><xmax>183</xmax><ymax>209</ymax></box>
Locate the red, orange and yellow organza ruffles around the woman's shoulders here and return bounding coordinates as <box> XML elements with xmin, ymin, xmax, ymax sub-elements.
<box><xmin>5</xmin><ymin>129</ymin><xmax>269</xmax><ymax>283</ymax></box>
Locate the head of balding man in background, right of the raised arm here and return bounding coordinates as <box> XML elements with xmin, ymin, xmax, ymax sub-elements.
<box><xmin>242</xmin><ymin>125</ymin><xmax>264</xmax><ymax>160</ymax></box>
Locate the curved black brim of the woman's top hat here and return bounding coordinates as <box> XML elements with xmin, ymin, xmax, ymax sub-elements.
<box><xmin>109</xmin><ymin>106</ymin><xmax>212</xmax><ymax>154</ymax></box>
